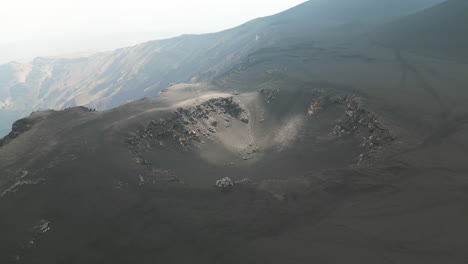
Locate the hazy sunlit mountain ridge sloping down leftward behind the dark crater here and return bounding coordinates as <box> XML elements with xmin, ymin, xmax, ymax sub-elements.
<box><xmin>0</xmin><ymin>0</ymin><xmax>446</xmax><ymax>134</ymax></box>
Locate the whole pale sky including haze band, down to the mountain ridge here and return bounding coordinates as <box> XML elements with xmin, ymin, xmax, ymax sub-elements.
<box><xmin>0</xmin><ymin>0</ymin><xmax>305</xmax><ymax>64</ymax></box>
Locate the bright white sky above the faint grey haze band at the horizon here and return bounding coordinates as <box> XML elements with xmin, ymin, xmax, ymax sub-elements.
<box><xmin>0</xmin><ymin>0</ymin><xmax>304</xmax><ymax>42</ymax></box>
